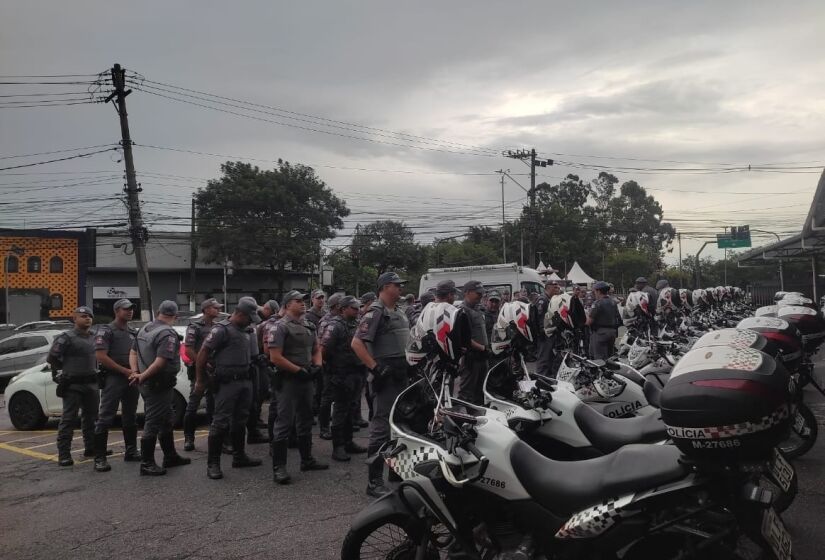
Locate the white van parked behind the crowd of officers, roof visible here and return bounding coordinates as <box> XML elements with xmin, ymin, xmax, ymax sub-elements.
<box><xmin>418</xmin><ymin>263</ymin><xmax>544</xmax><ymax>301</ymax></box>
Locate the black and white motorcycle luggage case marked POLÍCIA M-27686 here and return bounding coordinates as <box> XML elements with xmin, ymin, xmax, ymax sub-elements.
<box><xmin>661</xmin><ymin>346</ymin><xmax>791</xmax><ymax>462</ymax></box>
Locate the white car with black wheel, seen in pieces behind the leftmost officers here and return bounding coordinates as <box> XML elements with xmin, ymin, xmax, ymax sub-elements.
<box><xmin>0</xmin><ymin>327</ymin><xmax>200</xmax><ymax>430</ymax></box>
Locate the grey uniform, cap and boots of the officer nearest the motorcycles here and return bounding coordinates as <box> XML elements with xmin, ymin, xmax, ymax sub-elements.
<box><xmin>355</xmin><ymin>273</ymin><xmax>410</xmax><ymax>492</ymax></box>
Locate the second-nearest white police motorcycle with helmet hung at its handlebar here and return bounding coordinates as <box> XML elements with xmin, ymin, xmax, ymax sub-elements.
<box><xmin>484</xmin><ymin>302</ymin><xmax>667</xmax><ymax>460</ymax></box>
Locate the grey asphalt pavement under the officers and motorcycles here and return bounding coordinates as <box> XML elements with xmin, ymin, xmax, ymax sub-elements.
<box><xmin>0</xmin><ymin>382</ymin><xmax>825</xmax><ymax>560</ymax></box>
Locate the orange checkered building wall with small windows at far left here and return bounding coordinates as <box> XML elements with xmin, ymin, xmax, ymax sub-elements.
<box><xmin>0</xmin><ymin>237</ymin><xmax>80</xmax><ymax>317</ymax></box>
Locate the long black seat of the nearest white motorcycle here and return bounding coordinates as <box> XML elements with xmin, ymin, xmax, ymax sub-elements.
<box><xmin>510</xmin><ymin>441</ymin><xmax>689</xmax><ymax>517</ymax></box>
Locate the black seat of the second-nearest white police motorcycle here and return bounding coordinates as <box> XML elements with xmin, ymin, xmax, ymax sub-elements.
<box><xmin>573</xmin><ymin>404</ymin><xmax>667</xmax><ymax>453</ymax></box>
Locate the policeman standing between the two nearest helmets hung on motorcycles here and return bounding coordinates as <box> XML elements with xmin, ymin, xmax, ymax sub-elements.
<box><xmin>458</xmin><ymin>280</ymin><xmax>490</xmax><ymax>405</ymax></box>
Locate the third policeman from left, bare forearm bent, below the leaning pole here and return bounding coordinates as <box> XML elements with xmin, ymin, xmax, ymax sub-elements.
<box><xmin>129</xmin><ymin>300</ymin><xmax>191</xmax><ymax>476</ymax></box>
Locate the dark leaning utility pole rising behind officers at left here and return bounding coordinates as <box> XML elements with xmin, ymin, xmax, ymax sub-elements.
<box><xmin>106</xmin><ymin>64</ymin><xmax>153</xmax><ymax>321</ymax></box>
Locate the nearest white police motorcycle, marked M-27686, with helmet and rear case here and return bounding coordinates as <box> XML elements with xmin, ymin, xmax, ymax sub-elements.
<box><xmin>341</xmin><ymin>304</ymin><xmax>793</xmax><ymax>560</ymax></box>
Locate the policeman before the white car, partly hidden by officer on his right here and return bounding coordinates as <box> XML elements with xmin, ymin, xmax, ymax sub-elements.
<box><xmin>183</xmin><ymin>298</ymin><xmax>223</xmax><ymax>451</ymax></box>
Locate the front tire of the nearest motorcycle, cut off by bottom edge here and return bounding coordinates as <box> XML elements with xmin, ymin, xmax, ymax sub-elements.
<box><xmin>341</xmin><ymin>514</ymin><xmax>440</xmax><ymax>560</ymax></box>
